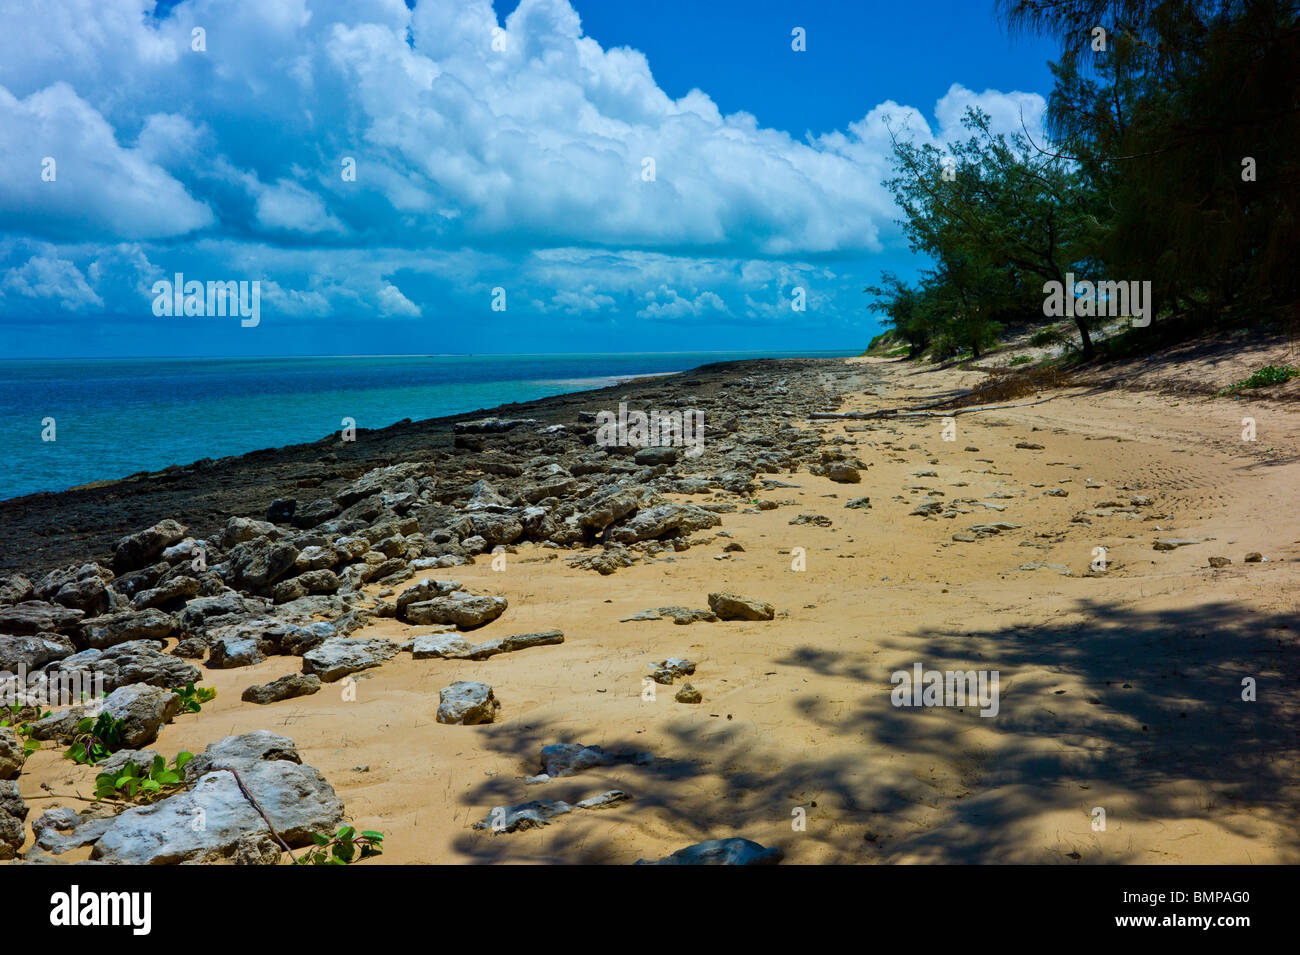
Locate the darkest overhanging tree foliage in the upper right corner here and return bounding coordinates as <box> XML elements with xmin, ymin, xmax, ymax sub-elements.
<box><xmin>1000</xmin><ymin>0</ymin><xmax>1300</xmax><ymax>322</ymax></box>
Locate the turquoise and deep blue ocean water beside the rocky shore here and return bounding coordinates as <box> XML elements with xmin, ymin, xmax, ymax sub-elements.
<box><xmin>0</xmin><ymin>352</ymin><xmax>852</xmax><ymax>499</ymax></box>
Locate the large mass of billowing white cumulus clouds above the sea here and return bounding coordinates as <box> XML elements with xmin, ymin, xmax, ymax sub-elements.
<box><xmin>0</xmin><ymin>0</ymin><xmax>1044</xmax><ymax>335</ymax></box>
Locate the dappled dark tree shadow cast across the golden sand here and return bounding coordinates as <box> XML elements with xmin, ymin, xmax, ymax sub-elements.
<box><xmin>441</xmin><ymin>600</ymin><xmax>1300</xmax><ymax>863</ymax></box>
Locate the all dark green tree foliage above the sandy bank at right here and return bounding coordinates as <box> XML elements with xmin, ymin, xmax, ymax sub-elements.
<box><xmin>868</xmin><ymin>0</ymin><xmax>1300</xmax><ymax>361</ymax></box>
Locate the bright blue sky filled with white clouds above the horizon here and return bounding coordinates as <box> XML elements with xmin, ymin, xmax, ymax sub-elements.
<box><xmin>0</xmin><ymin>0</ymin><xmax>1053</xmax><ymax>359</ymax></box>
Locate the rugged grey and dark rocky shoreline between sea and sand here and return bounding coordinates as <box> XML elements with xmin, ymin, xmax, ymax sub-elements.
<box><xmin>0</xmin><ymin>360</ymin><xmax>870</xmax><ymax>864</ymax></box>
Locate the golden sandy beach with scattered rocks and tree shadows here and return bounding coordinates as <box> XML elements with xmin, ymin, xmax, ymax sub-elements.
<box><xmin>8</xmin><ymin>345</ymin><xmax>1300</xmax><ymax>864</ymax></box>
